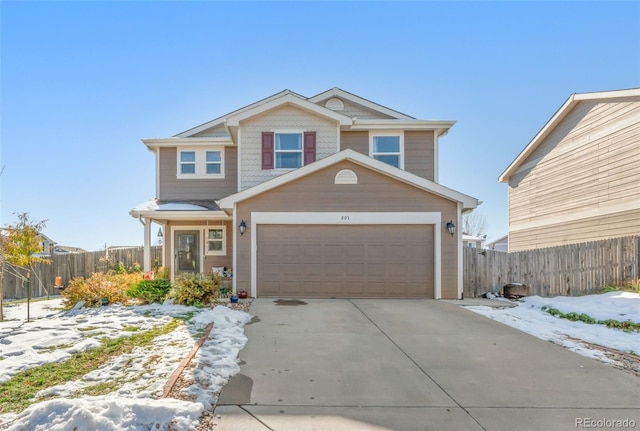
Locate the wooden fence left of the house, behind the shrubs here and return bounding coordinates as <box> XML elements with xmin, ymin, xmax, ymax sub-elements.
<box><xmin>2</xmin><ymin>246</ymin><xmax>162</xmax><ymax>299</ymax></box>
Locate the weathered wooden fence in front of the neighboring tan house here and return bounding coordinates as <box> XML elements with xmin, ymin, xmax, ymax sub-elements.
<box><xmin>463</xmin><ymin>236</ymin><xmax>640</xmax><ymax>297</ymax></box>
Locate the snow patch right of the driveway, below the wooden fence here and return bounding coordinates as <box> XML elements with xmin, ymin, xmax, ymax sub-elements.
<box><xmin>465</xmin><ymin>292</ymin><xmax>640</xmax><ymax>362</ymax></box>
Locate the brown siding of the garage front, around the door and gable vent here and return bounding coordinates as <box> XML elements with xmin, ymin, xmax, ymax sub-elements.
<box><xmin>234</xmin><ymin>161</ymin><xmax>458</xmax><ymax>298</ymax></box>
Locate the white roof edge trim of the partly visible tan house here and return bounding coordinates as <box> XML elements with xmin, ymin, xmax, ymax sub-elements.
<box><xmin>498</xmin><ymin>88</ymin><xmax>640</xmax><ymax>183</ymax></box>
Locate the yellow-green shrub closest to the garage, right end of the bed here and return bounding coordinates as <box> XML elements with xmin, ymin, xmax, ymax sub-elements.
<box><xmin>168</xmin><ymin>274</ymin><xmax>221</xmax><ymax>306</ymax></box>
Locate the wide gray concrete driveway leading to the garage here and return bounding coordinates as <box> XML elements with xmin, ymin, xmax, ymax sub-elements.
<box><xmin>213</xmin><ymin>299</ymin><xmax>640</xmax><ymax>431</ymax></box>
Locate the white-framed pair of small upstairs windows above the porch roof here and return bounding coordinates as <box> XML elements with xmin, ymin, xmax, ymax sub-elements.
<box><xmin>177</xmin><ymin>147</ymin><xmax>224</xmax><ymax>179</ymax></box>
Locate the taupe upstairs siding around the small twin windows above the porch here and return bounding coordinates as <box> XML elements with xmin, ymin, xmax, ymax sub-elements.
<box><xmin>158</xmin><ymin>147</ymin><xmax>238</xmax><ymax>201</ymax></box>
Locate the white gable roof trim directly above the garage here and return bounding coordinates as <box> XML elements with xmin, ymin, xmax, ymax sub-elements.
<box><xmin>218</xmin><ymin>149</ymin><xmax>480</xmax><ymax>210</ymax></box>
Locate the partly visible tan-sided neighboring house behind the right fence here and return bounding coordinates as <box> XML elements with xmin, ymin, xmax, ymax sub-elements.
<box><xmin>499</xmin><ymin>88</ymin><xmax>640</xmax><ymax>252</ymax></box>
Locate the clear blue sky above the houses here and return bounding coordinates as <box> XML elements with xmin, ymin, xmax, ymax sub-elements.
<box><xmin>0</xmin><ymin>1</ymin><xmax>640</xmax><ymax>250</ymax></box>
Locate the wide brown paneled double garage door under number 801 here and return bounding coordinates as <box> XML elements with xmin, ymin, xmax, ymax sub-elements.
<box><xmin>256</xmin><ymin>225</ymin><xmax>433</xmax><ymax>298</ymax></box>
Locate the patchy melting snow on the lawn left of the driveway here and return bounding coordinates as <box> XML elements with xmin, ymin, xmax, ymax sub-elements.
<box><xmin>0</xmin><ymin>300</ymin><xmax>251</xmax><ymax>431</ymax></box>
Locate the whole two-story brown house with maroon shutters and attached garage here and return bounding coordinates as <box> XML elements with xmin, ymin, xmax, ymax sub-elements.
<box><xmin>131</xmin><ymin>88</ymin><xmax>478</xmax><ymax>298</ymax></box>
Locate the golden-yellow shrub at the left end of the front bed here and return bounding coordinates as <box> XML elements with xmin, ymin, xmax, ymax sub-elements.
<box><xmin>62</xmin><ymin>272</ymin><xmax>142</xmax><ymax>308</ymax></box>
